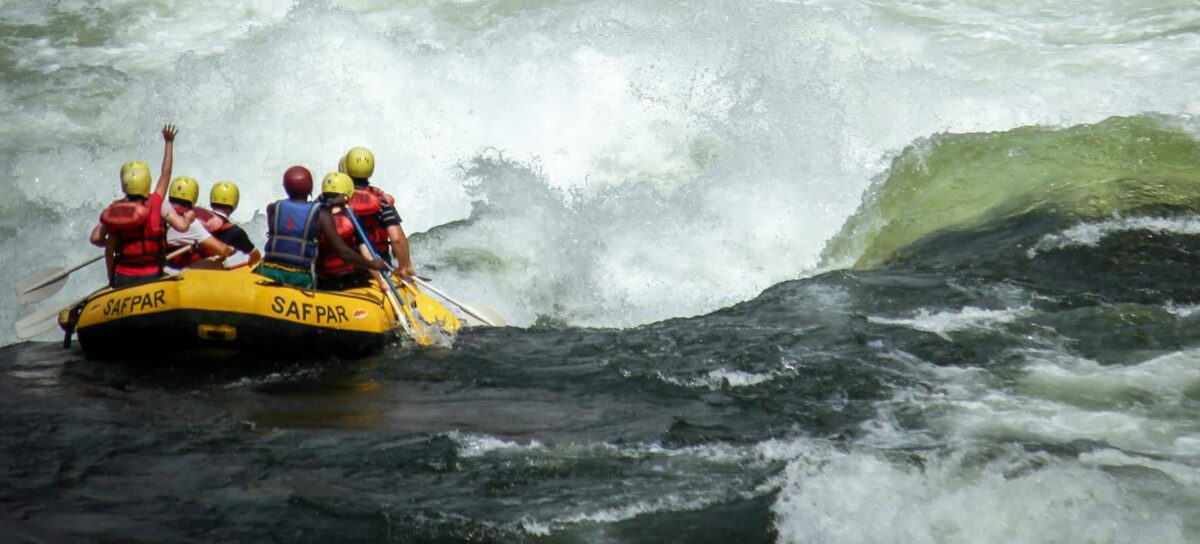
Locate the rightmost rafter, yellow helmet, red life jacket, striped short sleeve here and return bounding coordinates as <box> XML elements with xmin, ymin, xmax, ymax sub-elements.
<box><xmin>343</xmin><ymin>148</ymin><xmax>414</xmax><ymax>281</ymax></box>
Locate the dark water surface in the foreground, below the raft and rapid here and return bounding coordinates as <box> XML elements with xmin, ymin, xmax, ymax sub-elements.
<box><xmin>7</xmin><ymin>207</ymin><xmax>1200</xmax><ymax>543</ymax></box>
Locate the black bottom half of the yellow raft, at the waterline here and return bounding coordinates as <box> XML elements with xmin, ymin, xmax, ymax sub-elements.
<box><xmin>78</xmin><ymin>310</ymin><xmax>394</xmax><ymax>358</ymax></box>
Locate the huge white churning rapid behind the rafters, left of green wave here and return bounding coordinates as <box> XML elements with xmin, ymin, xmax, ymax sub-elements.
<box><xmin>0</xmin><ymin>1</ymin><xmax>1200</xmax><ymax>341</ymax></box>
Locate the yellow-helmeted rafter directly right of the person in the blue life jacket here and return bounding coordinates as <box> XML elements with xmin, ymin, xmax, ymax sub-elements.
<box><xmin>317</xmin><ymin>172</ymin><xmax>385</xmax><ymax>291</ymax></box>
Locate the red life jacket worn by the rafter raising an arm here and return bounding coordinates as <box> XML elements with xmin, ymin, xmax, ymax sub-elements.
<box><xmin>100</xmin><ymin>195</ymin><xmax>167</xmax><ymax>276</ymax></box>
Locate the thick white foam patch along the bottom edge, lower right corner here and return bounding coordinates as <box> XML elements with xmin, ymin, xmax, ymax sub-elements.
<box><xmin>774</xmin><ymin>441</ymin><xmax>1188</xmax><ymax>544</ymax></box>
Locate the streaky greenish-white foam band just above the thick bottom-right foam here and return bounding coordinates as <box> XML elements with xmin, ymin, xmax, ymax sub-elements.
<box><xmin>863</xmin><ymin>349</ymin><xmax>1200</xmax><ymax>455</ymax></box>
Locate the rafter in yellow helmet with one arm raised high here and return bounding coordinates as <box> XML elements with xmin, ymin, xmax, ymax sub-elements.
<box><xmin>91</xmin><ymin>125</ymin><xmax>192</xmax><ymax>288</ymax></box>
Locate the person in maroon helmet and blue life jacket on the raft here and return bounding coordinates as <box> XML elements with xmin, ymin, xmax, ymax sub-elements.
<box><xmin>254</xmin><ymin>166</ymin><xmax>385</xmax><ymax>289</ymax></box>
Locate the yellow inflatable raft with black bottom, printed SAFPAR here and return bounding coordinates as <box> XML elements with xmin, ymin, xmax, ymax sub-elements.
<box><xmin>59</xmin><ymin>268</ymin><xmax>462</xmax><ymax>357</ymax></box>
